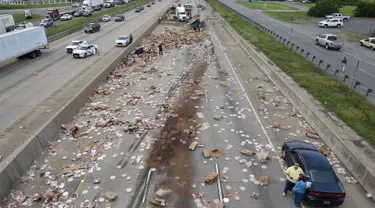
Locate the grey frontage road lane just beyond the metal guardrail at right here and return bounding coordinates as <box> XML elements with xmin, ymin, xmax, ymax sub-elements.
<box><xmin>222</xmin><ymin>1</ymin><xmax>375</xmax><ymax>83</ymax></box>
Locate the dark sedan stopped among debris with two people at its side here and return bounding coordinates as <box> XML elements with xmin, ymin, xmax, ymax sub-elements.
<box><xmin>282</xmin><ymin>141</ymin><xmax>346</xmax><ymax>205</ymax></box>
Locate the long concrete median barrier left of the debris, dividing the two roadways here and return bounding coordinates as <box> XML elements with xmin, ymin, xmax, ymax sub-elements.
<box><xmin>0</xmin><ymin>8</ymin><xmax>168</xmax><ymax>202</ymax></box>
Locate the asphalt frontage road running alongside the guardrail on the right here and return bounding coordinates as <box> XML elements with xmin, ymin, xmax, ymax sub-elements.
<box><xmin>219</xmin><ymin>0</ymin><xmax>375</xmax><ymax>89</ymax></box>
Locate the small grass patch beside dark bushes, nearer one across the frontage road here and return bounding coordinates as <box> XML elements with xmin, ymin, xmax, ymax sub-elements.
<box><xmin>264</xmin><ymin>11</ymin><xmax>316</xmax><ymax>24</ymax></box>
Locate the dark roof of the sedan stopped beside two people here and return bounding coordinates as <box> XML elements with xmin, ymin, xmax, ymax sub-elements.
<box><xmin>296</xmin><ymin>150</ymin><xmax>332</xmax><ymax>170</ymax></box>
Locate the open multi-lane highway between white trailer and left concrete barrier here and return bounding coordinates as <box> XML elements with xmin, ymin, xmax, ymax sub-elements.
<box><xmin>0</xmin><ymin>1</ymin><xmax>171</xmax><ymax>156</ymax></box>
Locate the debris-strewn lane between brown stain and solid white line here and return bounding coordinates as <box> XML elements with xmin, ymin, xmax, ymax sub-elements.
<box><xmin>205</xmin><ymin>19</ymin><xmax>293</xmax><ymax>208</ymax></box>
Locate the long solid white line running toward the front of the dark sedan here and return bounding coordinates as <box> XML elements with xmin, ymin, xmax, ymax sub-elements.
<box><xmin>208</xmin><ymin>15</ymin><xmax>305</xmax><ymax>208</ymax></box>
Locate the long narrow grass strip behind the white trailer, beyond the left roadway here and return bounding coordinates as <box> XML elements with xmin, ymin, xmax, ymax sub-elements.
<box><xmin>46</xmin><ymin>0</ymin><xmax>150</xmax><ymax>37</ymax></box>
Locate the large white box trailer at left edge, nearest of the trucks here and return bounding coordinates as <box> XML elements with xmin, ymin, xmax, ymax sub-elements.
<box><xmin>0</xmin><ymin>27</ymin><xmax>48</xmax><ymax>63</ymax></box>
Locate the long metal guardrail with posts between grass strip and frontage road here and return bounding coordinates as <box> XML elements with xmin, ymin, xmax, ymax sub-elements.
<box><xmin>217</xmin><ymin>1</ymin><xmax>375</xmax><ymax>104</ymax></box>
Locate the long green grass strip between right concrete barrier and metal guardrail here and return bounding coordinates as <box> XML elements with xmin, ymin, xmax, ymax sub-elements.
<box><xmin>207</xmin><ymin>0</ymin><xmax>375</xmax><ymax>145</ymax></box>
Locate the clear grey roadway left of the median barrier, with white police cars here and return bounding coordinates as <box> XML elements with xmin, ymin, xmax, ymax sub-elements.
<box><xmin>0</xmin><ymin>1</ymin><xmax>172</xmax><ymax>133</ymax></box>
